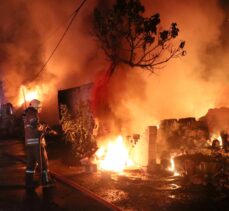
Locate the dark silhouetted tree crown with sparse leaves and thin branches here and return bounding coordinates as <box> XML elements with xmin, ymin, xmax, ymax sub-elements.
<box><xmin>94</xmin><ymin>0</ymin><xmax>185</xmax><ymax>76</ymax></box>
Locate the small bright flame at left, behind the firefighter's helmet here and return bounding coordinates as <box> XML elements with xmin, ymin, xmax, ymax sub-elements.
<box><xmin>17</xmin><ymin>85</ymin><xmax>48</xmax><ymax>107</ymax></box>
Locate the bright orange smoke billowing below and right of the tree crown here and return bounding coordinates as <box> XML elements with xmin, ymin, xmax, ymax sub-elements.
<box><xmin>93</xmin><ymin>0</ymin><xmax>229</xmax><ymax>132</ymax></box>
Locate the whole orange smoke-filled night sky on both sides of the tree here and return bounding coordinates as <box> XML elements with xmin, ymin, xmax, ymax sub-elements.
<box><xmin>0</xmin><ymin>0</ymin><xmax>229</xmax><ymax>131</ymax></box>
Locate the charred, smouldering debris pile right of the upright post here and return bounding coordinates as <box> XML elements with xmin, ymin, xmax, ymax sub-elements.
<box><xmin>159</xmin><ymin>113</ymin><xmax>229</xmax><ymax>187</ymax></box>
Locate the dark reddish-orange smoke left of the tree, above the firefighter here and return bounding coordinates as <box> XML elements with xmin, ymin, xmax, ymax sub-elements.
<box><xmin>0</xmin><ymin>0</ymin><xmax>104</xmax><ymax>122</ymax></box>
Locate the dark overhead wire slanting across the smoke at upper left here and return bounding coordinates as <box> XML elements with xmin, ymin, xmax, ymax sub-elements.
<box><xmin>31</xmin><ymin>0</ymin><xmax>87</xmax><ymax>82</ymax></box>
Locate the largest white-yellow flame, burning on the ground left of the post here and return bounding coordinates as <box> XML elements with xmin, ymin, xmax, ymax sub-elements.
<box><xmin>96</xmin><ymin>135</ymin><xmax>133</xmax><ymax>172</ymax></box>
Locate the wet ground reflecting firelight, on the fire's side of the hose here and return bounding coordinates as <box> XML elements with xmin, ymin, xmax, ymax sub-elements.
<box><xmin>1</xmin><ymin>140</ymin><xmax>229</xmax><ymax>211</ymax></box>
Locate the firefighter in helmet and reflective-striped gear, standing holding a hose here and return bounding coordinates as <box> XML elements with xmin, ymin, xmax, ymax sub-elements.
<box><xmin>24</xmin><ymin>99</ymin><xmax>52</xmax><ymax>191</ymax></box>
